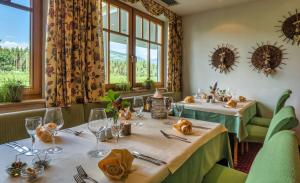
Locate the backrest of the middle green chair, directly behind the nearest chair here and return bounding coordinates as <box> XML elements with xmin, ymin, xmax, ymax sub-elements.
<box><xmin>265</xmin><ymin>106</ymin><xmax>298</xmax><ymax>142</ymax></box>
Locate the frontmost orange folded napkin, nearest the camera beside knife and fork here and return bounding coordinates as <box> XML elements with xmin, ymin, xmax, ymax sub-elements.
<box><xmin>98</xmin><ymin>149</ymin><xmax>134</xmax><ymax>180</ymax></box>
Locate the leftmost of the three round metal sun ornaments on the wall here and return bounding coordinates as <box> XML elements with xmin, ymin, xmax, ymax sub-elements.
<box><xmin>209</xmin><ymin>44</ymin><xmax>239</xmax><ymax>74</ymax></box>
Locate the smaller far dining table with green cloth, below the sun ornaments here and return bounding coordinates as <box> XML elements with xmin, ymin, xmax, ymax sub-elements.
<box><xmin>172</xmin><ymin>99</ymin><xmax>257</xmax><ymax>165</ymax></box>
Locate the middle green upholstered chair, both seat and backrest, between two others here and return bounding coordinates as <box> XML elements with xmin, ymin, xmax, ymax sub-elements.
<box><xmin>244</xmin><ymin>106</ymin><xmax>298</xmax><ymax>142</ymax></box>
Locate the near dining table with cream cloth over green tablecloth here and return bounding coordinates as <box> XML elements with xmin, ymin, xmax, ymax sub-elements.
<box><xmin>0</xmin><ymin>113</ymin><xmax>232</xmax><ymax>183</ymax></box>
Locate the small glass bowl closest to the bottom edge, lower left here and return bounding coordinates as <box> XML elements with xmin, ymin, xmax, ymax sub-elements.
<box><xmin>21</xmin><ymin>166</ymin><xmax>45</xmax><ymax>182</ymax></box>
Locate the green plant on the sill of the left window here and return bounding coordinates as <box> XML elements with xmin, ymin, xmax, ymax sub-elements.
<box><xmin>0</xmin><ymin>78</ymin><xmax>24</xmax><ymax>102</ymax></box>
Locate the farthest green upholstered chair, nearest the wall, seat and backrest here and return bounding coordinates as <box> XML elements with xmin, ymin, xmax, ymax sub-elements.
<box><xmin>249</xmin><ymin>90</ymin><xmax>292</xmax><ymax>127</ymax></box>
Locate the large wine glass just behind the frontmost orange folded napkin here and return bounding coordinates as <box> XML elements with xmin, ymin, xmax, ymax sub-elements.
<box><xmin>88</xmin><ymin>108</ymin><xmax>108</xmax><ymax>158</ymax></box>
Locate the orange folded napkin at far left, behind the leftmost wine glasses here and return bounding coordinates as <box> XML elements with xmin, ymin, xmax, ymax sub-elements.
<box><xmin>35</xmin><ymin>123</ymin><xmax>56</xmax><ymax>143</ymax></box>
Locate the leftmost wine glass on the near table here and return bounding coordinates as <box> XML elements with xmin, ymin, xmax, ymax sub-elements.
<box><xmin>25</xmin><ymin>116</ymin><xmax>43</xmax><ymax>156</ymax></box>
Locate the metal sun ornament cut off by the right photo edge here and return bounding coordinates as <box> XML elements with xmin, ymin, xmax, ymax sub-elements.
<box><xmin>275</xmin><ymin>9</ymin><xmax>300</xmax><ymax>46</ymax></box>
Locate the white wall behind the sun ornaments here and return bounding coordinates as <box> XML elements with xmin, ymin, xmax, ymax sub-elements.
<box><xmin>183</xmin><ymin>0</ymin><xmax>300</xmax><ymax>137</ymax></box>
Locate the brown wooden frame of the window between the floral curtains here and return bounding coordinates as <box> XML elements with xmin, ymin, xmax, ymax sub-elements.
<box><xmin>103</xmin><ymin>0</ymin><xmax>165</xmax><ymax>90</ymax></box>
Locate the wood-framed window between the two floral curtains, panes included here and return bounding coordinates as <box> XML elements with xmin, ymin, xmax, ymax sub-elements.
<box><xmin>102</xmin><ymin>0</ymin><xmax>164</xmax><ymax>86</ymax></box>
